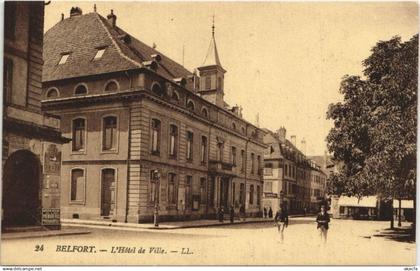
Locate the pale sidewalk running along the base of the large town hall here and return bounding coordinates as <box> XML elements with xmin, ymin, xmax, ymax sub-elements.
<box><xmin>61</xmin><ymin>215</ymin><xmax>312</xmax><ymax>230</ymax></box>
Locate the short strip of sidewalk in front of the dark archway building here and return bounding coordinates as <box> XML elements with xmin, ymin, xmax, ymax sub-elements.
<box><xmin>1</xmin><ymin>228</ymin><xmax>90</xmax><ymax>240</ymax></box>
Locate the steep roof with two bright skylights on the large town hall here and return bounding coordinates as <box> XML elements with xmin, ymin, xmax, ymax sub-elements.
<box><xmin>43</xmin><ymin>13</ymin><xmax>192</xmax><ymax>81</ymax></box>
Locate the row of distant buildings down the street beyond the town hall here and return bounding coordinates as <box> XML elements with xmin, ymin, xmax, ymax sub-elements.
<box><xmin>262</xmin><ymin>127</ymin><xmax>326</xmax><ymax>214</ymax></box>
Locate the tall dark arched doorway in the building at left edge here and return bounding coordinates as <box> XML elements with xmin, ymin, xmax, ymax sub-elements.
<box><xmin>2</xmin><ymin>150</ymin><xmax>41</xmax><ymax>226</ymax></box>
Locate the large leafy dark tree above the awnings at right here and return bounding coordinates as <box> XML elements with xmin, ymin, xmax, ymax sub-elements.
<box><xmin>327</xmin><ymin>35</ymin><xmax>418</xmax><ymax>230</ymax></box>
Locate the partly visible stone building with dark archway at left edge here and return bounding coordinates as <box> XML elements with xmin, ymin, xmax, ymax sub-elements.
<box><xmin>2</xmin><ymin>2</ymin><xmax>66</xmax><ymax>230</ymax></box>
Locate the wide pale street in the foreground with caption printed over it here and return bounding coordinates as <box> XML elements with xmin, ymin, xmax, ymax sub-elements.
<box><xmin>1</xmin><ymin>217</ymin><xmax>416</xmax><ymax>265</ymax></box>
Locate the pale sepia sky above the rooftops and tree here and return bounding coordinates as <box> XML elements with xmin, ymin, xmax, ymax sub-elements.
<box><xmin>45</xmin><ymin>1</ymin><xmax>418</xmax><ymax>155</ymax></box>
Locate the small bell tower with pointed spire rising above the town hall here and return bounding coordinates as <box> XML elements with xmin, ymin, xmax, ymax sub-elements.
<box><xmin>197</xmin><ymin>16</ymin><xmax>226</xmax><ymax>107</ymax></box>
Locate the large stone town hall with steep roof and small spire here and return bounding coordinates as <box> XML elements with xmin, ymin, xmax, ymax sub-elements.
<box><xmin>42</xmin><ymin>8</ymin><xmax>265</xmax><ymax>223</ymax></box>
